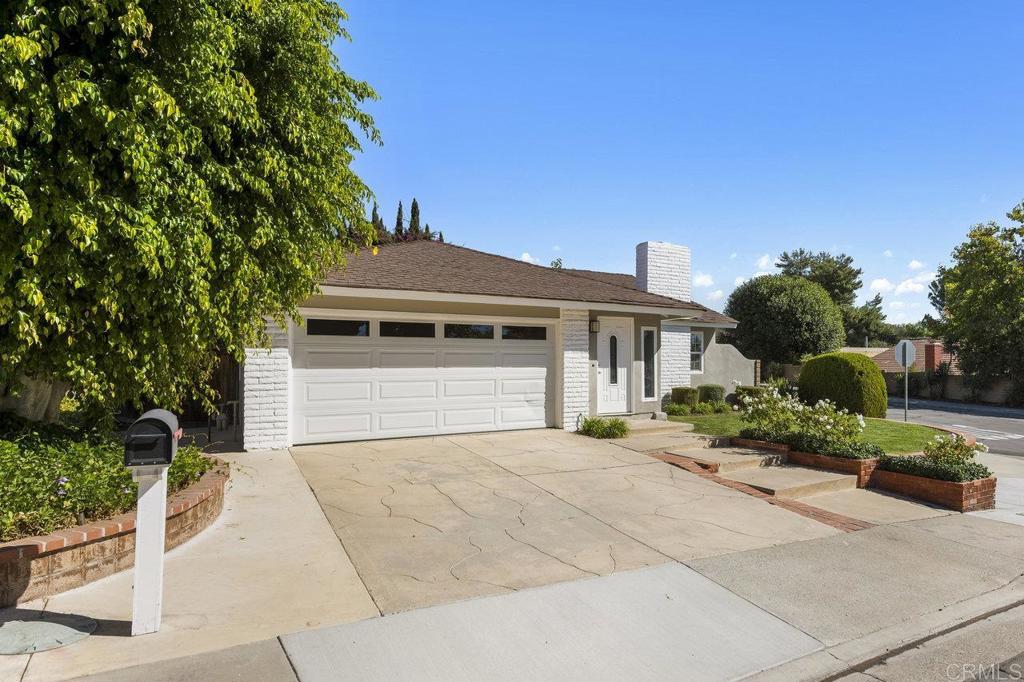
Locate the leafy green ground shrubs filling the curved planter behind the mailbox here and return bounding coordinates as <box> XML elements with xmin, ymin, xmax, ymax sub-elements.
<box><xmin>0</xmin><ymin>417</ymin><xmax>213</xmax><ymax>542</ymax></box>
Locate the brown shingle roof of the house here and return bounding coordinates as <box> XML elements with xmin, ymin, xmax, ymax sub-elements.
<box><xmin>324</xmin><ymin>241</ymin><xmax>732</xmax><ymax>322</ymax></box>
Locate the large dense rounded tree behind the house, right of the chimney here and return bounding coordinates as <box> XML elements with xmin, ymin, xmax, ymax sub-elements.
<box><xmin>724</xmin><ymin>274</ymin><xmax>844</xmax><ymax>364</ymax></box>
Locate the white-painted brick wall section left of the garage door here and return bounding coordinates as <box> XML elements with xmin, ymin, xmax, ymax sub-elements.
<box><xmin>242</xmin><ymin>322</ymin><xmax>292</xmax><ymax>451</ymax></box>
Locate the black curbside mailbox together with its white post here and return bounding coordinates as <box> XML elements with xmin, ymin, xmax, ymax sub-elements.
<box><xmin>125</xmin><ymin>410</ymin><xmax>181</xmax><ymax>637</ymax></box>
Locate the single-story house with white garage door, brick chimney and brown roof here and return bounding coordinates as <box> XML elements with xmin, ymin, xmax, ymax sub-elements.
<box><xmin>243</xmin><ymin>236</ymin><xmax>755</xmax><ymax>450</ymax></box>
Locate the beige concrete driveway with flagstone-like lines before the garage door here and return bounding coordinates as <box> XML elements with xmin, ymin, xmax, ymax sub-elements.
<box><xmin>292</xmin><ymin>429</ymin><xmax>837</xmax><ymax>612</ymax></box>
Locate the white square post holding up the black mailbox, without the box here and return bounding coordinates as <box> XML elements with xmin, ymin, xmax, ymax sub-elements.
<box><xmin>131</xmin><ymin>466</ymin><xmax>167</xmax><ymax>637</ymax></box>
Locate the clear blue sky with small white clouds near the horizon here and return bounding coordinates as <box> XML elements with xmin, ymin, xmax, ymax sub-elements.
<box><xmin>335</xmin><ymin>0</ymin><xmax>1024</xmax><ymax>322</ymax></box>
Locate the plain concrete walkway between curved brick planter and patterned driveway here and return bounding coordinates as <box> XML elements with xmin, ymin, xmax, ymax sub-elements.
<box><xmin>0</xmin><ymin>452</ymin><xmax>379</xmax><ymax>682</ymax></box>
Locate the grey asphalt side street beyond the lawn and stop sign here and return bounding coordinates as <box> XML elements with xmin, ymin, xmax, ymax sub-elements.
<box><xmin>887</xmin><ymin>398</ymin><xmax>1024</xmax><ymax>457</ymax></box>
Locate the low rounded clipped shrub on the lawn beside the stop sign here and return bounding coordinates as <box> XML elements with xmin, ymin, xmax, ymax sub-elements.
<box><xmin>800</xmin><ymin>352</ymin><xmax>888</xmax><ymax>417</ymax></box>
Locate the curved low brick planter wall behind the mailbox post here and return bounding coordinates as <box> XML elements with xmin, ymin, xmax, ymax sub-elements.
<box><xmin>0</xmin><ymin>460</ymin><xmax>228</xmax><ymax>607</ymax></box>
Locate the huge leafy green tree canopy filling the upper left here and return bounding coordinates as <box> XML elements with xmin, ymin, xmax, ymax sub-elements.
<box><xmin>0</xmin><ymin>0</ymin><xmax>378</xmax><ymax>418</ymax></box>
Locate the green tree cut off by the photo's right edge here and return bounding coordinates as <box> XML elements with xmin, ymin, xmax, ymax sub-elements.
<box><xmin>932</xmin><ymin>204</ymin><xmax>1024</xmax><ymax>402</ymax></box>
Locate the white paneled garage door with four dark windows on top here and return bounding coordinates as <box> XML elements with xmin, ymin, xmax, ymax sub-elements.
<box><xmin>292</xmin><ymin>316</ymin><xmax>554</xmax><ymax>443</ymax></box>
